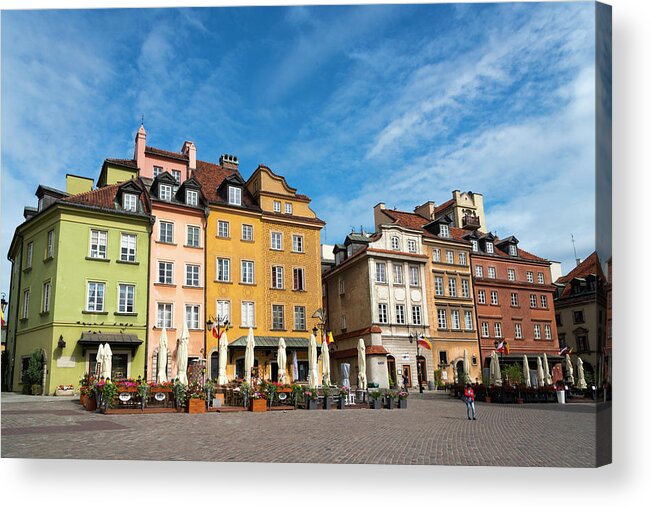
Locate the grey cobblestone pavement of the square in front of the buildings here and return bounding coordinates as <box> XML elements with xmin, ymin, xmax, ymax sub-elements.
<box><xmin>2</xmin><ymin>393</ymin><xmax>611</xmax><ymax>467</ymax></box>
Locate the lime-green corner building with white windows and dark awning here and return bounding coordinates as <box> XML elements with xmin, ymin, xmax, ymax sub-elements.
<box><xmin>6</xmin><ymin>175</ymin><xmax>152</xmax><ymax>394</ymax></box>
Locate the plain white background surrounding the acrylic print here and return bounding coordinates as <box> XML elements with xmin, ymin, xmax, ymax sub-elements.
<box><xmin>0</xmin><ymin>0</ymin><xmax>651</xmax><ymax>507</ymax></box>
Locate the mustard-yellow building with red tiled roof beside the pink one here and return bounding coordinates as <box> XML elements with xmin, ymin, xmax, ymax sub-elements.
<box><xmin>193</xmin><ymin>155</ymin><xmax>325</xmax><ymax>380</ymax></box>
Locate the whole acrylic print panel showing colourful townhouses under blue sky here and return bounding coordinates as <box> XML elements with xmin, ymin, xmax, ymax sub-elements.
<box><xmin>2</xmin><ymin>2</ymin><xmax>613</xmax><ymax>468</ymax></box>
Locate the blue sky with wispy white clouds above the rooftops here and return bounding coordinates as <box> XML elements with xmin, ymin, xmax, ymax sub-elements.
<box><xmin>0</xmin><ymin>2</ymin><xmax>595</xmax><ymax>292</ymax></box>
